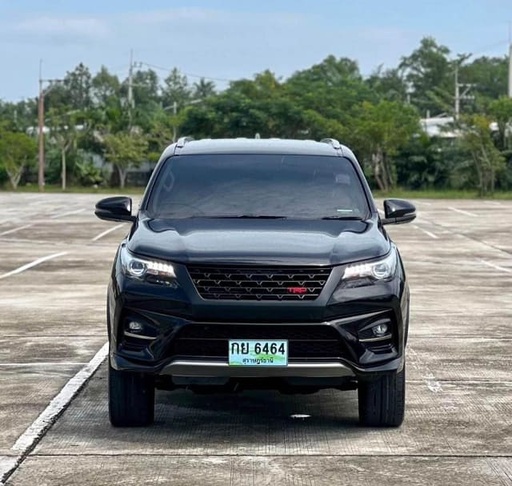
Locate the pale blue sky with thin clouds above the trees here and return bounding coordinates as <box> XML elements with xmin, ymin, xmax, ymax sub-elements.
<box><xmin>0</xmin><ymin>0</ymin><xmax>512</xmax><ymax>101</ymax></box>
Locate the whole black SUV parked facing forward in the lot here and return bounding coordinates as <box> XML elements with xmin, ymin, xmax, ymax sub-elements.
<box><xmin>96</xmin><ymin>138</ymin><xmax>415</xmax><ymax>426</ymax></box>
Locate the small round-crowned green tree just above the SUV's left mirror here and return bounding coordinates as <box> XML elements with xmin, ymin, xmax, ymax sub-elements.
<box><xmin>104</xmin><ymin>131</ymin><xmax>148</xmax><ymax>188</ymax></box>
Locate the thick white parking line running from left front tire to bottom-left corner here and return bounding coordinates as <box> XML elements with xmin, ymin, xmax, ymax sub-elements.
<box><xmin>0</xmin><ymin>343</ymin><xmax>108</xmax><ymax>484</ymax></box>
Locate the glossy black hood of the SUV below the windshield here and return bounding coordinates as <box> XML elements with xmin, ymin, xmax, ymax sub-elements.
<box><xmin>128</xmin><ymin>219</ymin><xmax>390</xmax><ymax>265</ymax></box>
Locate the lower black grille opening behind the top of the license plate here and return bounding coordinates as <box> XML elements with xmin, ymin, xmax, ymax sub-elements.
<box><xmin>170</xmin><ymin>324</ymin><xmax>344</xmax><ymax>359</ymax></box>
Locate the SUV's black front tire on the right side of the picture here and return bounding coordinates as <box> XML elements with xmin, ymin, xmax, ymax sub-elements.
<box><xmin>358</xmin><ymin>364</ymin><xmax>405</xmax><ymax>427</ymax></box>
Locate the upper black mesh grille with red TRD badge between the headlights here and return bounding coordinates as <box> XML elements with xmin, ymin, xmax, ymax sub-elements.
<box><xmin>188</xmin><ymin>266</ymin><xmax>331</xmax><ymax>301</ymax></box>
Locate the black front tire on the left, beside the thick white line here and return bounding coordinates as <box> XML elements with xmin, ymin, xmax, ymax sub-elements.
<box><xmin>108</xmin><ymin>363</ymin><xmax>155</xmax><ymax>427</ymax></box>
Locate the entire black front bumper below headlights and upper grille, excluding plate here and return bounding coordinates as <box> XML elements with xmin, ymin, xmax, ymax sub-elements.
<box><xmin>108</xmin><ymin>256</ymin><xmax>409</xmax><ymax>380</ymax></box>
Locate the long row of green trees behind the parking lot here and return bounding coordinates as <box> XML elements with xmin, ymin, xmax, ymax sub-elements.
<box><xmin>0</xmin><ymin>37</ymin><xmax>512</xmax><ymax>195</ymax></box>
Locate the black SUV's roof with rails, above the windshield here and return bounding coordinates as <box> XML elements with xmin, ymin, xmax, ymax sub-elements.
<box><xmin>162</xmin><ymin>138</ymin><xmax>354</xmax><ymax>158</ymax></box>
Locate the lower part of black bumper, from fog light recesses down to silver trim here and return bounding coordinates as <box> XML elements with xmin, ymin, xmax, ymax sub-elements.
<box><xmin>110</xmin><ymin>309</ymin><xmax>403</xmax><ymax>379</ymax></box>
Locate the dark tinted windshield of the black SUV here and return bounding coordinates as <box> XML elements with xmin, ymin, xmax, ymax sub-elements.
<box><xmin>147</xmin><ymin>154</ymin><xmax>369</xmax><ymax>219</ymax></box>
